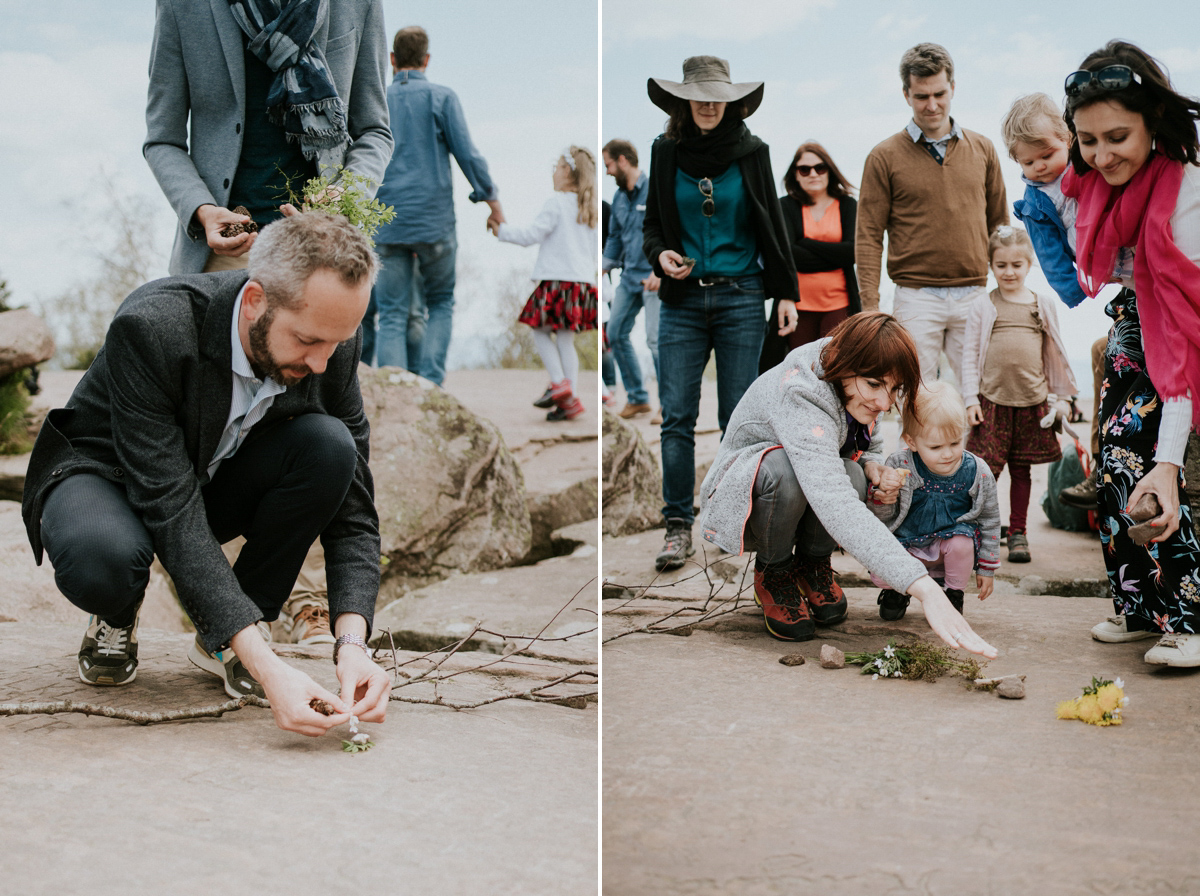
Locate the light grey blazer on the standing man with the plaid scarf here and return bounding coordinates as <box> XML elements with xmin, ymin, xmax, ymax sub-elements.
<box><xmin>142</xmin><ymin>0</ymin><xmax>392</xmax><ymax>273</ymax></box>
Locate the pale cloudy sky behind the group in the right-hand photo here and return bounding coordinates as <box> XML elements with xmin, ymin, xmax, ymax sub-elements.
<box><xmin>601</xmin><ymin>0</ymin><xmax>1200</xmax><ymax>371</ymax></box>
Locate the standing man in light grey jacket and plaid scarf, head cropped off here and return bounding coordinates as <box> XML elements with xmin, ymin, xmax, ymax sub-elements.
<box><xmin>142</xmin><ymin>0</ymin><xmax>392</xmax><ymax>273</ymax></box>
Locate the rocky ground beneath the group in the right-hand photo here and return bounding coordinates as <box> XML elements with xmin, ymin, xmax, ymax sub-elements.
<box><xmin>602</xmin><ymin>390</ymin><xmax>1200</xmax><ymax>896</ymax></box>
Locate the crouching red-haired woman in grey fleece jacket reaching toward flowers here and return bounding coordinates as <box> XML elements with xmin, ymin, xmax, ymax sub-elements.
<box><xmin>700</xmin><ymin>312</ymin><xmax>996</xmax><ymax>657</ymax></box>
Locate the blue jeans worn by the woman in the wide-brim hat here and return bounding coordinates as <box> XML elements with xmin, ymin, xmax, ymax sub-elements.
<box><xmin>659</xmin><ymin>276</ymin><xmax>767</xmax><ymax>523</ymax></box>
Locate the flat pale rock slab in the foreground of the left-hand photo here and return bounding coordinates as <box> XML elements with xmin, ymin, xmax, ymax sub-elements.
<box><xmin>0</xmin><ymin>624</ymin><xmax>596</xmax><ymax>896</ymax></box>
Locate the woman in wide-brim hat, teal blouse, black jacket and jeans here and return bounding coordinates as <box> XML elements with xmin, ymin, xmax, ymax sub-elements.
<box><xmin>644</xmin><ymin>56</ymin><xmax>797</xmax><ymax>571</ymax></box>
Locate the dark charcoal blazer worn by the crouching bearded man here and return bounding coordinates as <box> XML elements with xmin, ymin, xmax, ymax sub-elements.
<box><xmin>22</xmin><ymin>271</ymin><xmax>379</xmax><ymax>650</ymax></box>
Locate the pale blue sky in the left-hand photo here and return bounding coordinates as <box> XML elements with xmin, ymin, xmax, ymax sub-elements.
<box><xmin>0</xmin><ymin>0</ymin><xmax>599</xmax><ymax>364</ymax></box>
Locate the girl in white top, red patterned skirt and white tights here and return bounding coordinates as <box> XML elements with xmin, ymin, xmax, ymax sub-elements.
<box><xmin>487</xmin><ymin>146</ymin><xmax>598</xmax><ymax>420</ymax></box>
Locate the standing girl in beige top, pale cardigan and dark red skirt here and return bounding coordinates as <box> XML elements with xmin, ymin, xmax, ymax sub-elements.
<box><xmin>962</xmin><ymin>224</ymin><xmax>1076</xmax><ymax>563</ymax></box>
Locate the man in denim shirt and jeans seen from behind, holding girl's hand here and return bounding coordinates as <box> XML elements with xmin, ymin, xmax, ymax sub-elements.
<box><xmin>366</xmin><ymin>25</ymin><xmax>504</xmax><ymax>385</ymax></box>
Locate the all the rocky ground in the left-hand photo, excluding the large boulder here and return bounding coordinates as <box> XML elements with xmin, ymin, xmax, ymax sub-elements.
<box><xmin>0</xmin><ymin>371</ymin><xmax>598</xmax><ymax>896</ymax></box>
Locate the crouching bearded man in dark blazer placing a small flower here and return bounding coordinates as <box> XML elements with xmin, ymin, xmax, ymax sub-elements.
<box><xmin>22</xmin><ymin>212</ymin><xmax>389</xmax><ymax>735</ymax></box>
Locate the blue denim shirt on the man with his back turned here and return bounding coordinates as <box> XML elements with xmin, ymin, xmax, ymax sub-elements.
<box><xmin>376</xmin><ymin>70</ymin><xmax>499</xmax><ymax>246</ymax></box>
